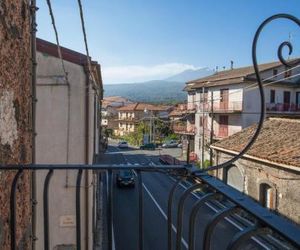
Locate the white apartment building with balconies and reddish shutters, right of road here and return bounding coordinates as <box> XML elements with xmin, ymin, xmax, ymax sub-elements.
<box><xmin>184</xmin><ymin>62</ymin><xmax>300</xmax><ymax>164</ymax></box>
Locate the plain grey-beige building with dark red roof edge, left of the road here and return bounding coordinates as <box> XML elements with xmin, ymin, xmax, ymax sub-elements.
<box><xmin>36</xmin><ymin>39</ymin><xmax>102</xmax><ymax>250</ymax></box>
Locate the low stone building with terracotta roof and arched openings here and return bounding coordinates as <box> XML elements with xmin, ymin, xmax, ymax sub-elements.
<box><xmin>211</xmin><ymin>118</ymin><xmax>300</xmax><ymax>224</ymax></box>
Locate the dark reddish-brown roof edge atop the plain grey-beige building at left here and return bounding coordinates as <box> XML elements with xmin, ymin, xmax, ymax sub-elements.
<box><xmin>36</xmin><ymin>38</ymin><xmax>97</xmax><ymax>65</ymax></box>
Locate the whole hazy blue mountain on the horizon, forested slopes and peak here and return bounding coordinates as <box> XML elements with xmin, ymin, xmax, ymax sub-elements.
<box><xmin>104</xmin><ymin>68</ymin><xmax>213</xmax><ymax>104</ymax></box>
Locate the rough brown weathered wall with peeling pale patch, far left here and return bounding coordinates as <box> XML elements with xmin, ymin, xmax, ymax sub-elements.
<box><xmin>0</xmin><ymin>0</ymin><xmax>31</xmax><ymax>249</ymax></box>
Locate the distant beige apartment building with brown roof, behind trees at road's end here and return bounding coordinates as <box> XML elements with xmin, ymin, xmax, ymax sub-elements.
<box><xmin>115</xmin><ymin>102</ymin><xmax>170</xmax><ymax>136</ymax></box>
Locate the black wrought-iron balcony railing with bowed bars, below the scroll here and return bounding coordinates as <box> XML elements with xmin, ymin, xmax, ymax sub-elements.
<box><xmin>0</xmin><ymin>164</ymin><xmax>300</xmax><ymax>250</ymax></box>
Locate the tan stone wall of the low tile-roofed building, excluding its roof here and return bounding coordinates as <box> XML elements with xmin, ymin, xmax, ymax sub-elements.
<box><xmin>215</xmin><ymin>151</ymin><xmax>300</xmax><ymax>224</ymax></box>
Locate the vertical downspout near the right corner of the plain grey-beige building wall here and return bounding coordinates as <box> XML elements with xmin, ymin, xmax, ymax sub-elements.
<box><xmin>84</xmin><ymin>67</ymin><xmax>90</xmax><ymax>250</ymax></box>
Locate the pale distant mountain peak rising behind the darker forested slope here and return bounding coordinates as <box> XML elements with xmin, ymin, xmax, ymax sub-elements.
<box><xmin>165</xmin><ymin>68</ymin><xmax>214</xmax><ymax>82</ymax></box>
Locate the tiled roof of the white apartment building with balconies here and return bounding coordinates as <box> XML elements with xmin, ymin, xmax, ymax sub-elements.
<box><xmin>184</xmin><ymin>59</ymin><xmax>297</xmax><ymax>91</ymax></box>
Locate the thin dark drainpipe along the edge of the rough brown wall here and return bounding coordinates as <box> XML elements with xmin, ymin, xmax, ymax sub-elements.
<box><xmin>30</xmin><ymin>0</ymin><xmax>38</xmax><ymax>250</ymax></box>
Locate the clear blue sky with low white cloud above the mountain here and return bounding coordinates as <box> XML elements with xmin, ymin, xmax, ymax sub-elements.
<box><xmin>37</xmin><ymin>0</ymin><xmax>300</xmax><ymax>84</ymax></box>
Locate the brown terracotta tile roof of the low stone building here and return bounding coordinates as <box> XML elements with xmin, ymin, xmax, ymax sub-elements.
<box><xmin>212</xmin><ymin>118</ymin><xmax>300</xmax><ymax>167</ymax></box>
